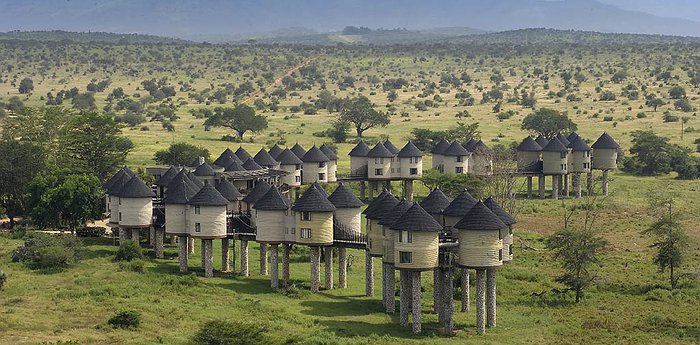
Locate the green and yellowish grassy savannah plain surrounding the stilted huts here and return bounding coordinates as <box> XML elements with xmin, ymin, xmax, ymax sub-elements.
<box><xmin>0</xmin><ymin>36</ymin><xmax>700</xmax><ymax>344</ymax></box>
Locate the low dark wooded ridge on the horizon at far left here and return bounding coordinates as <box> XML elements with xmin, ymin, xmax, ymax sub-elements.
<box><xmin>0</xmin><ymin>30</ymin><xmax>194</xmax><ymax>44</ymax></box>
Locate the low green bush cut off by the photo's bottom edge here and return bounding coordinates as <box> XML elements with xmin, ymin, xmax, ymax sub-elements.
<box><xmin>192</xmin><ymin>320</ymin><xmax>267</xmax><ymax>345</ymax></box>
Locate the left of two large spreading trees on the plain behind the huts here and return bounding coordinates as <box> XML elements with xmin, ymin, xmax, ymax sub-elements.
<box><xmin>204</xmin><ymin>104</ymin><xmax>267</xmax><ymax>139</ymax></box>
